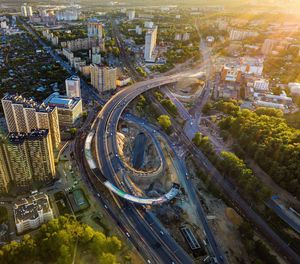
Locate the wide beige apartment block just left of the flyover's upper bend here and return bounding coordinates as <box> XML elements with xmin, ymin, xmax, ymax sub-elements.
<box><xmin>90</xmin><ymin>64</ymin><xmax>117</xmax><ymax>93</ymax></box>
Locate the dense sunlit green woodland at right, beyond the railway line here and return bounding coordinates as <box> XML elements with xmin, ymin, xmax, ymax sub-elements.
<box><xmin>219</xmin><ymin>104</ymin><xmax>300</xmax><ymax>198</ymax></box>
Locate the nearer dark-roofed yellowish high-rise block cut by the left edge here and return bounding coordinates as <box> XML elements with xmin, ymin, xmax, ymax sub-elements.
<box><xmin>0</xmin><ymin>129</ymin><xmax>55</xmax><ymax>187</ymax></box>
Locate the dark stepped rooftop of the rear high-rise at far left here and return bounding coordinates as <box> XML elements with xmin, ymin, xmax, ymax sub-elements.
<box><xmin>2</xmin><ymin>94</ymin><xmax>54</xmax><ymax>113</ymax></box>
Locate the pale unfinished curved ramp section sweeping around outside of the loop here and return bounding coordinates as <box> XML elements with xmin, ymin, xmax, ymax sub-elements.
<box><xmin>84</xmin><ymin>131</ymin><xmax>180</xmax><ymax>205</ymax></box>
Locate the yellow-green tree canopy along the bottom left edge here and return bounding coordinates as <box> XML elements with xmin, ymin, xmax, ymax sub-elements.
<box><xmin>0</xmin><ymin>216</ymin><xmax>122</xmax><ymax>264</ymax></box>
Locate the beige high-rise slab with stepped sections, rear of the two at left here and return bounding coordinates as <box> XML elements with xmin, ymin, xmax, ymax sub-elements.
<box><xmin>1</xmin><ymin>95</ymin><xmax>61</xmax><ymax>148</ymax></box>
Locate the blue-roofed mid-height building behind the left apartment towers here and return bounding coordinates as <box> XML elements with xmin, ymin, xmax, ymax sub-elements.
<box><xmin>44</xmin><ymin>93</ymin><xmax>82</xmax><ymax>128</ymax></box>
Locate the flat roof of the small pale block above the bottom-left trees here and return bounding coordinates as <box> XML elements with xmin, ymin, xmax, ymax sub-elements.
<box><xmin>14</xmin><ymin>193</ymin><xmax>52</xmax><ymax>224</ymax></box>
